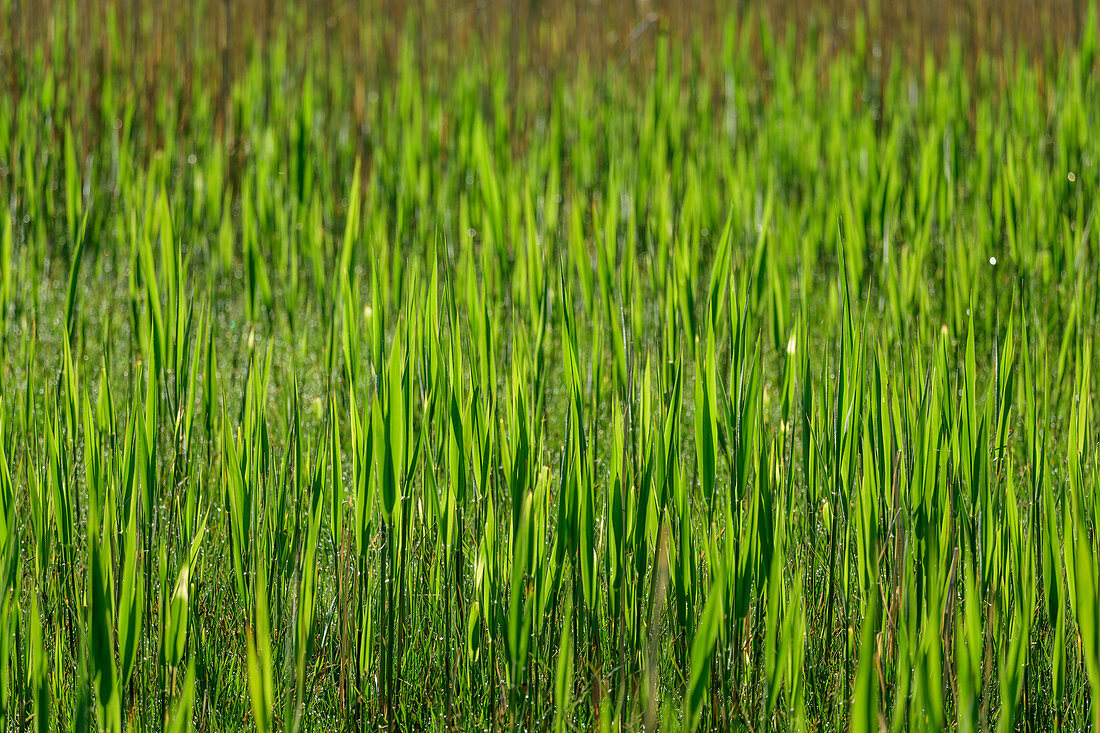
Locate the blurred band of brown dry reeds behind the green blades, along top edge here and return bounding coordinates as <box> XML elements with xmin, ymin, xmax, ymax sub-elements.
<box><xmin>0</xmin><ymin>0</ymin><xmax>1097</xmax><ymax>104</ymax></box>
